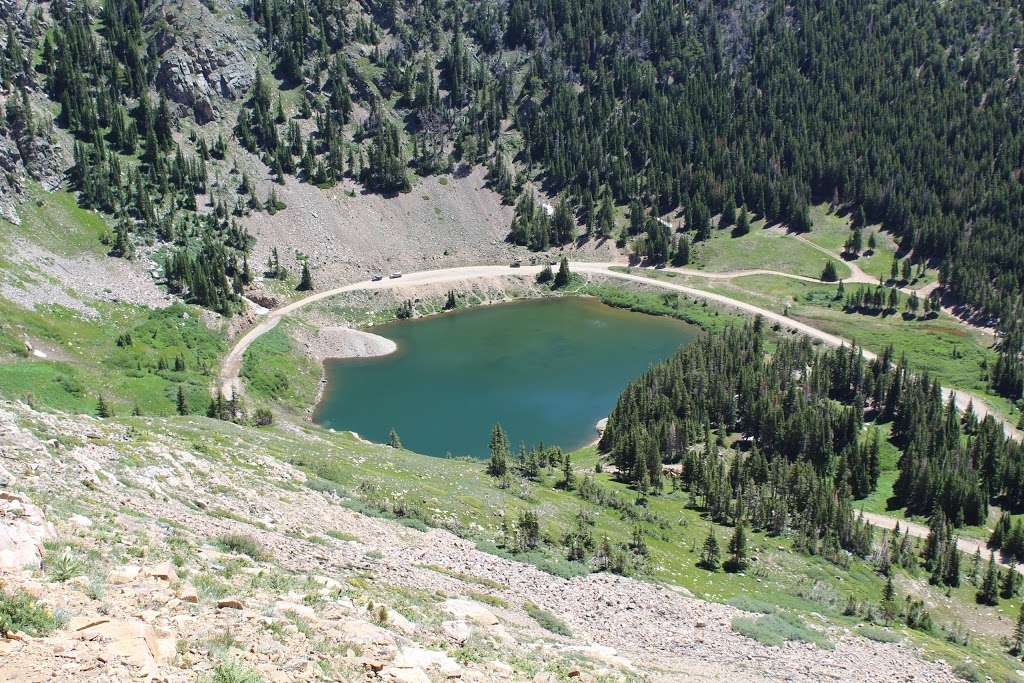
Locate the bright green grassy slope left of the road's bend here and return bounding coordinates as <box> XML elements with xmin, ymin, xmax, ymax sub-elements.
<box><xmin>0</xmin><ymin>189</ymin><xmax>226</xmax><ymax>415</ymax></box>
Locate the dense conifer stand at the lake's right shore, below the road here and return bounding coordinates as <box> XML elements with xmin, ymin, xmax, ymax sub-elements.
<box><xmin>600</xmin><ymin>319</ymin><xmax>1024</xmax><ymax>528</ymax></box>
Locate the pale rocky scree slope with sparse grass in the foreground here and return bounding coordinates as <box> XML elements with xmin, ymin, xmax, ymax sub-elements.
<box><xmin>0</xmin><ymin>402</ymin><xmax>953</xmax><ymax>682</ymax></box>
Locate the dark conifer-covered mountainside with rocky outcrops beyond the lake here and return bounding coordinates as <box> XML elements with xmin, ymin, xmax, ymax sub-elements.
<box><xmin>0</xmin><ymin>0</ymin><xmax>1024</xmax><ymax>321</ymax></box>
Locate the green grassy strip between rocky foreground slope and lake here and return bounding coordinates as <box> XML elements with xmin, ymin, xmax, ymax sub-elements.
<box><xmin>144</xmin><ymin>411</ymin><xmax>1019</xmax><ymax>680</ymax></box>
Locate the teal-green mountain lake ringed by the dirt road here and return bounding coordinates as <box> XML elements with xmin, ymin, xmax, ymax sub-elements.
<box><xmin>313</xmin><ymin>298</ymin><xmax>698</xmax><ymax>457</ymax></box>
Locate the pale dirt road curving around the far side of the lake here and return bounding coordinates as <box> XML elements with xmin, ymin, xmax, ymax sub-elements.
<box><xmin>219</xmin><ymin>261</ymin><xmax>1024</xmax><ymax>573</ymax></box>
